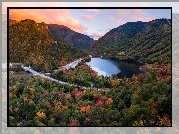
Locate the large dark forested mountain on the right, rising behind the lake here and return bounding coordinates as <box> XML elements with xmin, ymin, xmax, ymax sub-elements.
<box><xmin>85</xmin><ymin>19</ymin><xmax>171</xmax><ymax>64</ymax></box>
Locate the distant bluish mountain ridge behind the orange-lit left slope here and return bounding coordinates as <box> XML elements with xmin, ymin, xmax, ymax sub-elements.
<box><xmin>47</xmin><ymin>24</ymin><xmax>94</xmax><ymax>49</ymax></box>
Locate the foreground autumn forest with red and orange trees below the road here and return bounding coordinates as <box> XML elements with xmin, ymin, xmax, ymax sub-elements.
<box><xmin>9</xmin><ymin>62</ymin><xmax>172</xmax><ymax>126</ymax></box>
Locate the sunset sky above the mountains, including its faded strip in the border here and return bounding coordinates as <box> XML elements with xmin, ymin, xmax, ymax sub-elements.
<box><xmin>2</xmin><ymin>2</ymin><xmax>174</xmax><ymax>40</ymax></box>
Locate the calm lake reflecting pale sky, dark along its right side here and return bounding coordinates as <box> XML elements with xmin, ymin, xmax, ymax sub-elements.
<box><xmin>86</xmin><ymin>58</ymin><xmax>142</xmax><ymax>78</ymax></box>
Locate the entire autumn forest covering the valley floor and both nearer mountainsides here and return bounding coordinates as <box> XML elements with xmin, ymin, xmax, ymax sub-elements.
<box><xmin>8</xmin><ymin>19</ymin><xmax>172</xmax><ymax>126</ymax></box>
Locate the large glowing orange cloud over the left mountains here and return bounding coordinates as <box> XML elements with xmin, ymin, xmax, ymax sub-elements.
<box><xmin>9</xmin><ymin>9</ymin><xmax>87</xmax><ymax>33</ymax></box>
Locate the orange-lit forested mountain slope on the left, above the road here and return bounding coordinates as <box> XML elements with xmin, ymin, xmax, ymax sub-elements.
<box><xmin>9</xmin><ymin>19</ymin><xmax>86</xmax><ymax>72</ymax></box>
